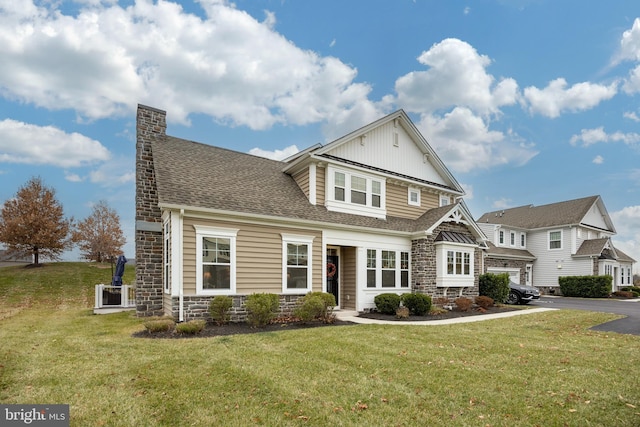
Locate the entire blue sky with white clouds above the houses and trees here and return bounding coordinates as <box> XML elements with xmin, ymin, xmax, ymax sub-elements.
<box><xmin>0</xmin><ymin>0</ymin><xmax>640</xmax><ymax>272</ymax></box>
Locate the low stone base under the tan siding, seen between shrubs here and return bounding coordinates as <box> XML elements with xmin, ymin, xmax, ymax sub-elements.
<box><xmin>171</xmin><ymin>295</ymin><xmax>304</xmax><ymax>322</ymax></box>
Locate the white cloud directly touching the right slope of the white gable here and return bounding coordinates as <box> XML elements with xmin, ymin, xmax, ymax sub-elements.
<box><xmin>418</xmin><ymin>108</ymin><xmax>538</xmax><ymax>172</ymax></box>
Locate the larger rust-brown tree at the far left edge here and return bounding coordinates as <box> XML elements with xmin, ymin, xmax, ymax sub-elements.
<box><xmin>0</xmin><ymin>177</ymin><xmax>73</xmax><ymax>266</ymax></box>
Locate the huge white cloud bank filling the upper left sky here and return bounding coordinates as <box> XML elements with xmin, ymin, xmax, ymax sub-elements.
<box><xmin>0</xmin><ymin>0</ymin><xmax>380</xmax><ymax>129</ymax></box>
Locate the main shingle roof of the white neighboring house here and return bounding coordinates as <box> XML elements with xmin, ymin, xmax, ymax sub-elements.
<box><xmin>477</xmin><ymin>196</ymin><xmax>599</xmax><ymax>230</ymax></box>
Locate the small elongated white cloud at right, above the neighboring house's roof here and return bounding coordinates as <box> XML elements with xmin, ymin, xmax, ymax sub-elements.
<box><xmin>524</xmin><ymin>78</ymin><xmax>618</xmax><ymax>118</ymax></box>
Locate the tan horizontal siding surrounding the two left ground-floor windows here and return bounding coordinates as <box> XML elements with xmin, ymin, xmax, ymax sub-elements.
<box><xmin>183</xmin><ymin>216</ymin><xmax>324</xmax><ymax>295</ymax></box>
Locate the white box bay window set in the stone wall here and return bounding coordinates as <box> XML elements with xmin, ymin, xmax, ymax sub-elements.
<box><xmin>436</xmin><ymin>242</ymin><xmax>475</xmax><ymax>287</ymax></box>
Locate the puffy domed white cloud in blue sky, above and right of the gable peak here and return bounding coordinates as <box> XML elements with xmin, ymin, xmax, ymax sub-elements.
<box><xmin>395</xmin><ymin>39</ymin><xmax>518</xmax><ymax>116</ymax></box>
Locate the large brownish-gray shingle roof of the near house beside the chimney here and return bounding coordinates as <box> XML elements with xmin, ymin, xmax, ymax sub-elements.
<box><xmin>152</xmin><ymin>136</ymin><xmax>458</xmax><ymax>232</ymax></box>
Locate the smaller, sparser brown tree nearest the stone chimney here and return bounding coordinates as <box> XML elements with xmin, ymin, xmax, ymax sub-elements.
<box><xmin>72</xmin><ymin>200</ymin><xmax>127</xmax><ymax>262</ymax></box>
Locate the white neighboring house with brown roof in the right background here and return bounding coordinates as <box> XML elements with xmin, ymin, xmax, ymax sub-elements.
<box><xmin>477</xmin><ymin>196</ymin><xmax>635</xmax><ymax>293</ymax></box>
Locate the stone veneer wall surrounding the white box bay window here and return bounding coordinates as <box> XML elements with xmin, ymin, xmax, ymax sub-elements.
<box><xmin>411</xmin><ymin>222</ymin><xmax>482</xmax><ymax>301</ymax></box>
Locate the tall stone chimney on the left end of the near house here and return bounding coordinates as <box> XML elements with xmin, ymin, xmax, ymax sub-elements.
<box><xmin>135</xmin><ymin>105</ymin><xmax>167</xmax><ymax>317</ymax></box>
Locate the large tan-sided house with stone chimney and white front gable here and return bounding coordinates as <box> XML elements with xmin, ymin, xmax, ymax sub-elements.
<box><xmin>136</xmin><ymin>105</ymin><xmax>485</xmax><ymax>320</ymax></box>
